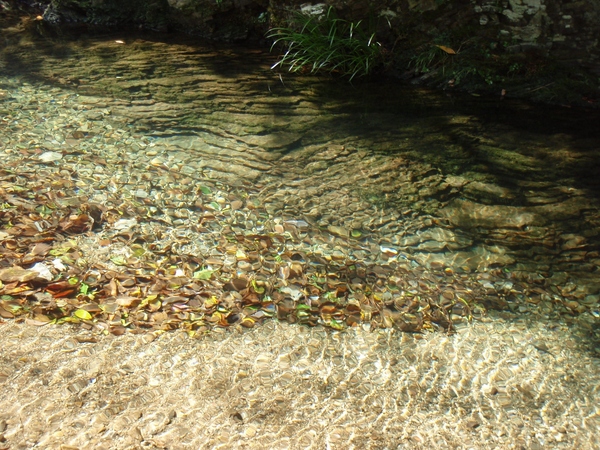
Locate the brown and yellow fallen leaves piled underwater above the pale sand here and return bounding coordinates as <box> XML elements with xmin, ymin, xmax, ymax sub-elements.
<box><xmin>0</xmin><ymin>132</ymin><xmax>489</xmax><ymax>336</ymax></box>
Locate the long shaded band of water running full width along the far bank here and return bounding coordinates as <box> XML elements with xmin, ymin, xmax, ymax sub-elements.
<box><xmin>0</xmin><ymin>22</ymin><xmax>600</xmax><ymax>215</ymax></box>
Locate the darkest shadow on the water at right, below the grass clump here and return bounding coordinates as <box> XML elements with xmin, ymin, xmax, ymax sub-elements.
<box><xmin>314</xmin><ymin>78</ymin><xmax>600</xmax><ymax>198</ymax></box>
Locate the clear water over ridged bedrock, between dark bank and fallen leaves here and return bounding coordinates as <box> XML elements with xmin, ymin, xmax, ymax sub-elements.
<box><xmin>2</xmin><ymin>29</ymin><xmax>600</xmax><ymax>330</ymax></box>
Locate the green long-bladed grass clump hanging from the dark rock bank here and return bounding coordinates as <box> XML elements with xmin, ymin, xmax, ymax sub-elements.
<box><xmin>267</xmin><ymin>7</ymin><xmax>382</xmax><ymax>80</ymax></box>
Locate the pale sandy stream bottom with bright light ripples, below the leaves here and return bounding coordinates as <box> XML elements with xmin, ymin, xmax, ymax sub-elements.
<box><xmin>0</xmin><ymin>318</ymin><xmax>600</xmax><ymax>449</ymax></box>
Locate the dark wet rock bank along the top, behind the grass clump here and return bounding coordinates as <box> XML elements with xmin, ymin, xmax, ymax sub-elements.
<box><xmin>36</xmin><ymin>0</ymin><xmax>600</xmax><ymax>73</ymax></box>
